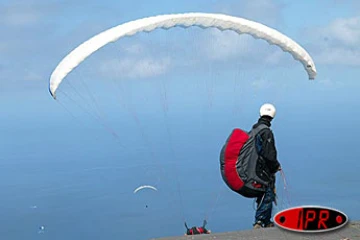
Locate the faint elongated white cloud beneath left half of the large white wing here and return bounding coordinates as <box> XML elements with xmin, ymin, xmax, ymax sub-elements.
<box><xmin>100</xmin><ymin>57</ymin><xmax>170</xmax><ymax>78</ymax></box>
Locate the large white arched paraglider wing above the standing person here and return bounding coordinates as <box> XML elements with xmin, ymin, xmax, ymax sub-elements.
<box><xmin>49</xmin><ymin>13</ymin><xmax>316</xmax><ymax>98</ymax></box>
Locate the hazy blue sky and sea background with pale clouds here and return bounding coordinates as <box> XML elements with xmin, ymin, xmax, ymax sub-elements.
<box><xmin>0</xmin><ymin>0</ymin><xmax>360</xmax><ymax>239</ymax></box>
